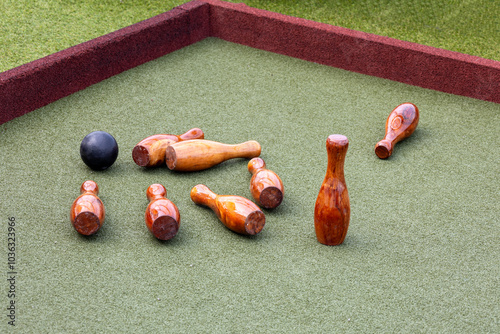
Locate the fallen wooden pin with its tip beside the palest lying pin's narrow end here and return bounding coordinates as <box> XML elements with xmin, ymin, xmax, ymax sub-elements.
<box><xmin>248</xmin><ymin>158</ymin><xmax>284</xmax><ymax>209</ymax></box>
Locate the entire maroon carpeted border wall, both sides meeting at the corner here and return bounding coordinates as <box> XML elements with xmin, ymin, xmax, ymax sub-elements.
<box><xmin>0</xmin><ymin>0</ymin><xmax>500</xmax><ymax>124</ymax></box>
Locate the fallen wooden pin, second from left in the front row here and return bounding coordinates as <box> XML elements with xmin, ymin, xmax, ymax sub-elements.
<box><xmin>144</xmin><ymin>184</ymin><xmax>181</xmax><ymax>240</ymax></box>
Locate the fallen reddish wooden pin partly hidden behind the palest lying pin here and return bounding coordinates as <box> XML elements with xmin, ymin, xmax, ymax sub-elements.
<box><xmin>132</xmin><ymin>128</ymin><xmax>204</xmax><ymax>167</ymax></box>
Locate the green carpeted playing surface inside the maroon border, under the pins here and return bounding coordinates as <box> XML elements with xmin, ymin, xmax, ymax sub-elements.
<box><xmin>0</xmin><ymin>38</ymin><xmax>500</xmax><ymax>333</ymax></box>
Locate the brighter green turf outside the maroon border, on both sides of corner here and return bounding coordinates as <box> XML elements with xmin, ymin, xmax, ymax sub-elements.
<box><xmin>0</xmin><ymin>0</ymin><xmax>500</xmax><ymax>71</ymax></box>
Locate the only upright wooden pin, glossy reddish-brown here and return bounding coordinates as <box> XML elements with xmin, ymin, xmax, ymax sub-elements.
<box><xmin>314</xmin><ymin>135</ymin><xmax>351</xmax><ymax>246</ymax></box>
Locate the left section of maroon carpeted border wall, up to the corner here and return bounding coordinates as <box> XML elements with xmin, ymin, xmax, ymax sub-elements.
<box><xmin>0</xmin><ymin>1</ymin><xmax>209</xmax><ymax>124</ymax></box>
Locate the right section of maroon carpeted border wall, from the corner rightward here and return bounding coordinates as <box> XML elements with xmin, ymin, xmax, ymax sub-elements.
<box><xmin>205</xmin><ymin>0</ymin><xmax>500</xmax><ymax>103</ymax></box>
